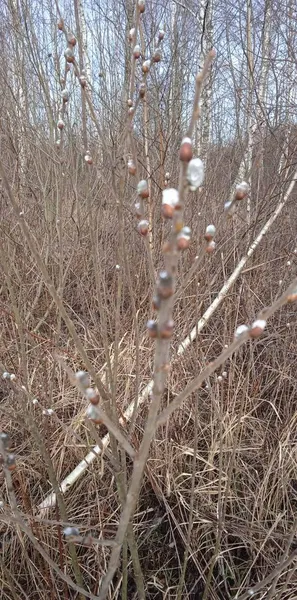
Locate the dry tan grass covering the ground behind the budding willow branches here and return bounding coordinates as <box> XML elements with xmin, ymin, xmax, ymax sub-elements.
<box><xmin>0</xmin><ymin>122</ymin><xmax>297</xmax><ymax>600</ymax></box>
